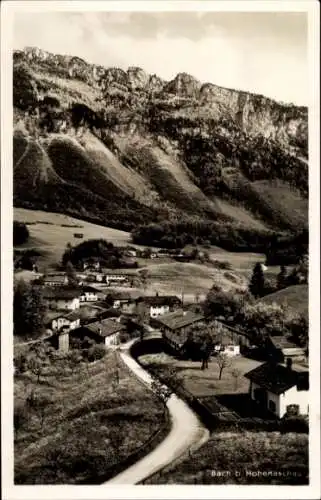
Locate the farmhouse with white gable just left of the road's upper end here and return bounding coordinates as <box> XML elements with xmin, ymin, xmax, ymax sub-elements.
<box><xmin>70</xmin><ymin>319</ymin><xmax>126</xmax><ymax>346</ymax></box>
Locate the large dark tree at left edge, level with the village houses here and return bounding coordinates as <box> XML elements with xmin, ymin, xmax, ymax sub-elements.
<box><xmin>13</xmin><ymin>280</ymin><xmax>45</xmax><ymax>338</ymax></box>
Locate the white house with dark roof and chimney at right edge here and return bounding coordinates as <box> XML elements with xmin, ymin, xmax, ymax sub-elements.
<box><xmin>245</xmin><ymin>359</ymin><xmax>309</xmax><ymax>418</ymax></box>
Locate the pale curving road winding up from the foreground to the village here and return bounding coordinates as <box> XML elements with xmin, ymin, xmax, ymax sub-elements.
<box><xmin>105</xmin><ymin>353</ymin><xmax>209</xmax><ymax>485</ymax></box>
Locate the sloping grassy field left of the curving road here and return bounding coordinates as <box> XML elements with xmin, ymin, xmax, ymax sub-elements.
<box><xmin>14</xmin><ymin>353</ymin><xmax>164</xmax><ymax>484</ymax></box>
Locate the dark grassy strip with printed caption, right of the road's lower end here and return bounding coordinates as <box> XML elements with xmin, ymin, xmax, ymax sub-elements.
<box><xmin>149</xmin><ymin>432</ymin><xmax>309</xmax><ymax>485</ymax></box>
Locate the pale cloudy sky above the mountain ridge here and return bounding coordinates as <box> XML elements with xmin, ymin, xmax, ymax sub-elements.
<box><xmin>13</xmin><ymin>11</ymin><xmax>308</xmax><ymax>105</ymax></box>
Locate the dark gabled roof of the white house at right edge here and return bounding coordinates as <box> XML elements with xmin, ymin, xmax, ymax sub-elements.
<box><xmin>244</xmin><ymin>362</ymin><xmax>307</xmax><ymax>395</ymax></box>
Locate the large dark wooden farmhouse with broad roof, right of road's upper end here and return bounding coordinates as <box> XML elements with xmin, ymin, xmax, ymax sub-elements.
<box><xmin>154</xmin><ymin>309</ymin><xmax>204</xmax><ymax>349</ymax></box>
